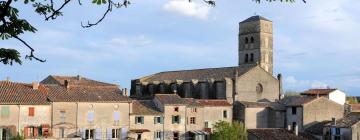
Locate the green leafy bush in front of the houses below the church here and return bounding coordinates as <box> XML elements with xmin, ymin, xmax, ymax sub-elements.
<box><xmin>211</xmin><ymin>121</ymin><xmax>247</xmax><ymax>140</ymax></box>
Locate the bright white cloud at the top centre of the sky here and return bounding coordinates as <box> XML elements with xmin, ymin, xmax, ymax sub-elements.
<box><xmin>163</xmin><ymin>0</ymin><xmax>210</xmax><ymax>19</ymax></box>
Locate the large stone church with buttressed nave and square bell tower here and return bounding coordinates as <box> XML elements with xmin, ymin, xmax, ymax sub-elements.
<box><xmin>130</xmin><ymin>16</ymin><xmax>281</xmax><ymax>103</ymax></box>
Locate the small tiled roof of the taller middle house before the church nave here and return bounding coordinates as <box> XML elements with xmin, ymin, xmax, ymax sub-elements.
<box><xmin>155</xmin><ymin>94</ymin><xmax>187</xmax><ymax>105</ymax></box>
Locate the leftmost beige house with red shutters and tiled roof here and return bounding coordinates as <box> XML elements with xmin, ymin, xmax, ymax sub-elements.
<box><xmin>0</xmin><ymin>81</ymin><xmax>51</xmax><ymax>139</ymax></box>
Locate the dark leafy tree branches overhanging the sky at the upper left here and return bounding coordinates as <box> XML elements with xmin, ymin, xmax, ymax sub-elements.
<box><xmin>0</xmin><ymin>0</ymin><xmax>305</xmax><ymax>65</ymax></box>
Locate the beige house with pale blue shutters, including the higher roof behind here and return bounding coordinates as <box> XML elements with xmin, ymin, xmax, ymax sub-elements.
<box><xmin>41</xmin><ymin>76</ymin><xmax>131</xmax><ymax>140</ymax></box>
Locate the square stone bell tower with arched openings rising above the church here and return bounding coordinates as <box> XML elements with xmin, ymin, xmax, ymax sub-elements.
<box><xmin>238</xmin><ymin>16</ymin><xmax>273</xmax><ymax>74</ymax></box>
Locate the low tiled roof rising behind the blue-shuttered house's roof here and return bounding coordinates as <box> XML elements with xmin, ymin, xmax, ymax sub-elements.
<box><xmin>40</xmin><ymin>75</ymin><xmax>117</xmax><ymax>87</ymax></box>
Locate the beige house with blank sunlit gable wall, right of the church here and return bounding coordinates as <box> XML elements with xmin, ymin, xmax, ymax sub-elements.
<box><xmin>281</xmin><ymin>96</ymin><xmax>344</xmax><ymax>132</ymax></box>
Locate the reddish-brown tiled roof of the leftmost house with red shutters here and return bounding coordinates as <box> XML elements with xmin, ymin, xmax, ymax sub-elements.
<box><xmin>0</xmin><ymin>81</ymin><xmax>49</xmax><ymax>105</ymax></box>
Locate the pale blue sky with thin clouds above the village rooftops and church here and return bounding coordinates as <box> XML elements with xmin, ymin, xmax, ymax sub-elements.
<box><xmin>0</xmin><ymin>0</ymin><xmax>360</xmax><ymax>95</ymax></box>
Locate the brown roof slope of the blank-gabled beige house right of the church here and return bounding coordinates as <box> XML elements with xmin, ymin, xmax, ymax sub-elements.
<box><xmin>280</xmin><ymin>96</ymin><xmax>317</xmax><ymax>106</ymax></box>
